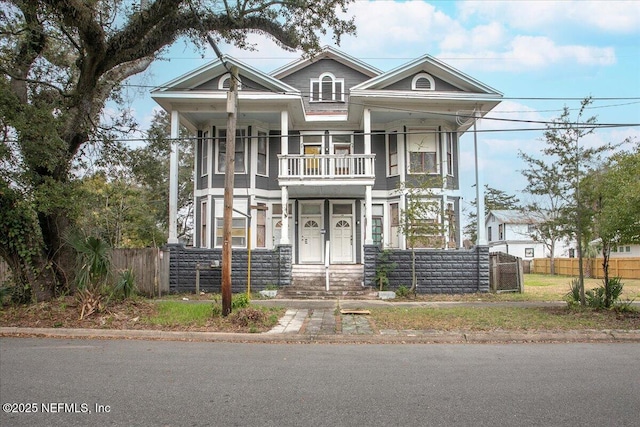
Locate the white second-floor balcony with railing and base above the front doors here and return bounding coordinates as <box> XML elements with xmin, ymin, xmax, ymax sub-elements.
<box><xmin>278</xmin><ymin>154</ymin><xmax>375</xmax><ymax>191</ymax></box>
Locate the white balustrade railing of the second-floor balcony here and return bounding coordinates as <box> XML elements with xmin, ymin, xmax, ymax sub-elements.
<box><xmin>278</xmin><ymin>154</ymin><xmax>375</xmax><ymax>180</ymax></box>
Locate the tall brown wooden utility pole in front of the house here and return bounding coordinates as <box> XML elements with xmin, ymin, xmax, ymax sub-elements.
<box><xmin>221</xmin><ymin>66</ymin><xmax>238</xmax><ymax>316</ymax></box>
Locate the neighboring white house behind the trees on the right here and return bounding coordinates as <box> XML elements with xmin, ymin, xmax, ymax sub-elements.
<box><xmin>485</xmin><ymin>210</ymin><xmax>576</xmax><ymax>260</ymax></box>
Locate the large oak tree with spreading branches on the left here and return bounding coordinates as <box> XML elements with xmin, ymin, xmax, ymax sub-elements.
<box><xmin>0</xmin><ymin>0</ymin><xmax>355</xmax><ymax>300</ymax></box>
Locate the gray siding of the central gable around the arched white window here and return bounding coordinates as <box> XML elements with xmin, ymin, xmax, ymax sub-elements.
<box><xmin>281</xmin><ymin>59</ymin><xmax>369</xmax><ymax>112</ymax></box>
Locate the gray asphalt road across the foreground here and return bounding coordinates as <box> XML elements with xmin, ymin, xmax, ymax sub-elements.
<box><xmin>0</xmin><ymin>338</ymin><xmax>640</xmax><ymax>427</ymax></box>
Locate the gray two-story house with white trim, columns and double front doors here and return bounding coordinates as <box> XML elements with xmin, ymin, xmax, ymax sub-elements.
<box><xmin>152</xmin><ymin>47</ymin><xmax>502</xmax><ymax>294</ymax></box>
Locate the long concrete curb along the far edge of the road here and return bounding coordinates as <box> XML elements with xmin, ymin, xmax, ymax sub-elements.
<box><xmin>0</xmin><ymin>327</ymin><xmax>640</xmax><ymax>344</ymax></box>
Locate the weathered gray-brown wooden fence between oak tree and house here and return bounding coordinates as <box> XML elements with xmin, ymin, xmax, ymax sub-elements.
<box><xmin>0</xmin><ymin>248</ymin><xmax>169</xmax><ymax>297</ymax></box>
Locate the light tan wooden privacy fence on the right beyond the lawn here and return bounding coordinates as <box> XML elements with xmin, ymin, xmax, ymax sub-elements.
<box><xmin>531</xmin><ymin>258</ymin><xmax>640</xmax><ymax>279</ymax></box>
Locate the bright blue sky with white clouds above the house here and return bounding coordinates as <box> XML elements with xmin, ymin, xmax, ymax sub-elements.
<box><xmin>121</xmin><ymin>0</ymin><xmax>640</xmax><ymax>217</ymax></box>
